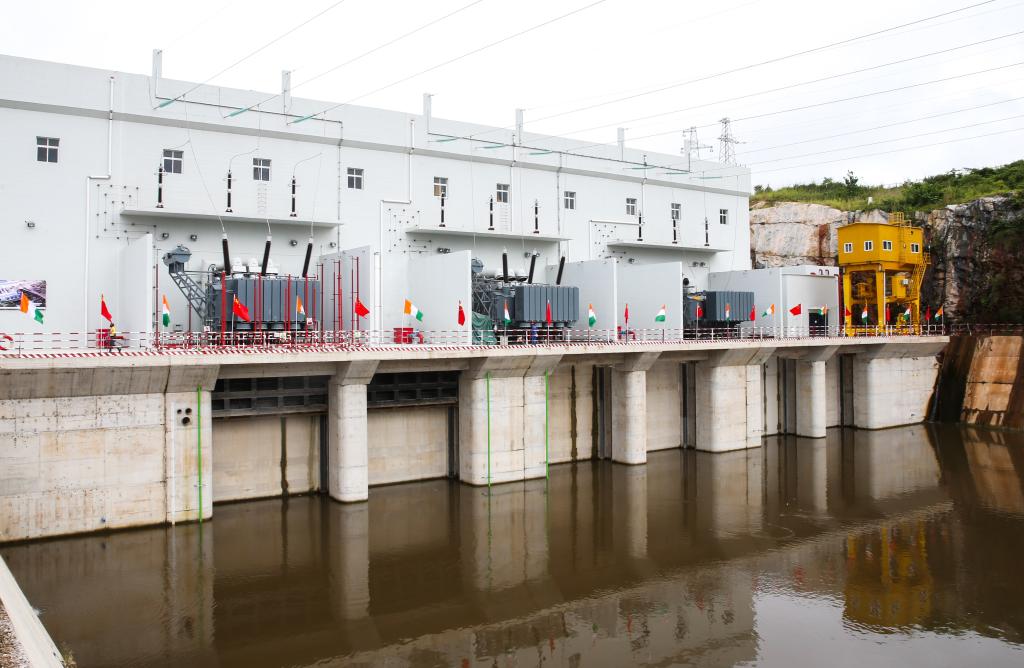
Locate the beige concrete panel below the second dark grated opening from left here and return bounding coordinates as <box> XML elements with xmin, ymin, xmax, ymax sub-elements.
<box><xmin>367</xmin><ymin>406</ymin><xmax>449</xmax><ymax>485</ymax></box>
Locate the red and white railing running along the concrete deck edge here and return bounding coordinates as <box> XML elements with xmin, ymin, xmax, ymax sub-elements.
<box><xmin>0</xmin><ymin>325</ymin><xmax>954</xmax><ymax>357</ymax></box>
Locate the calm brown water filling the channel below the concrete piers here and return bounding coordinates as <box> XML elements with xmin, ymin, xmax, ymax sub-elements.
<box><xmin>0</xmin><ymin>426</ymin><xmax>1024</xmax><ymax>668</ymax></box>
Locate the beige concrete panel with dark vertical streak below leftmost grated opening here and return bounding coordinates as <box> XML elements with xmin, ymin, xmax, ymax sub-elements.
<box><xmin>213</xmin><ymin>415</ymin><xmax>319</xmax><ymax>502</ymax></box>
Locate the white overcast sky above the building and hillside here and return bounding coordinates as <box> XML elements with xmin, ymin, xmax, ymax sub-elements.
<box><xmin>0</xmin><ymin>0</ymin><xmax>1024</xmax><ymax>186</ymax></box>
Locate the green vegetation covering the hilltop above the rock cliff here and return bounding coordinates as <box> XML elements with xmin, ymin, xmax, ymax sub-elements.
<box><xmin>751</xmin><ymin>160</ymin><xmax>1024</xmax><ymax>213</ymax></box>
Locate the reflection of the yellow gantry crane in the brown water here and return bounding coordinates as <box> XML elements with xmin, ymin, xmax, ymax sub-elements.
<box><xmin>844</xmin><ymin>519</ymin><xmax>934</xmax><ymax>628</ymax></box>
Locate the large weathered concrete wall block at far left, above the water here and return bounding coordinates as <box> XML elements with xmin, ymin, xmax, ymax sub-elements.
<box><xmin>0</xmin><ymin>394</ymin><xmax>167</xmax><ymax>541</ymax></box>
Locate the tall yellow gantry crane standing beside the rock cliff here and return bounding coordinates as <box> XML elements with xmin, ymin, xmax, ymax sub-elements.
<box><xmin>839</xmin><ymin>213</ymin><xmax>931</xmax><ymax>336</ymax></box>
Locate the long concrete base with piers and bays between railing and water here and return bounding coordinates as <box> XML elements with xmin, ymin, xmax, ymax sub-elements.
<box><xmin>0</xmin><ymin>336</ymin><xmax>946</xmax><ymax>541</ymax></box>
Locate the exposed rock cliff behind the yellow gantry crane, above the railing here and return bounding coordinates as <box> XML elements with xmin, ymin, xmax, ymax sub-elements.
<box><xmin>751</xmin><ymin>197</ymin><xmax>1024</xmax><ymax>323</ymax></box>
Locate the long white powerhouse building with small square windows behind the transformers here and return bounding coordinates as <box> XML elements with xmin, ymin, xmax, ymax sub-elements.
<box><xmin>0</xmin><ymin>54</ymin><xmax>750</xmax><ymax>340</ymax></box>
